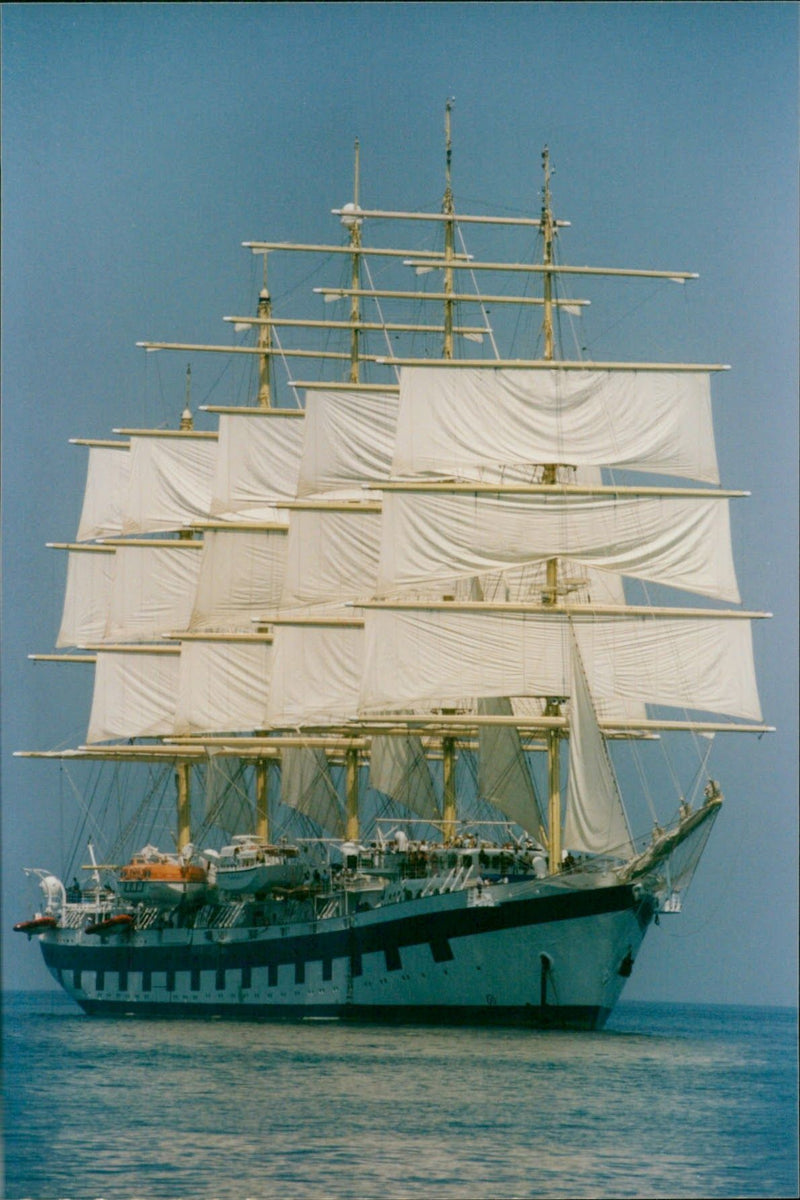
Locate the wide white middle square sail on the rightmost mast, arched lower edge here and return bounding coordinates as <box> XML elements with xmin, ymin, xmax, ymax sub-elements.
<box><xmin>377</xmin><ymin>491</ymin><xmax>739</xmax><ymax>602</ymax></box>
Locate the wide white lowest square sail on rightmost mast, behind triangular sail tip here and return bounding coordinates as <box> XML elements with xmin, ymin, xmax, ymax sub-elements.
<box><xmin>361</xmin><ymin>607</ymin><xmax>760</xmax><ymax>720</ymax></box>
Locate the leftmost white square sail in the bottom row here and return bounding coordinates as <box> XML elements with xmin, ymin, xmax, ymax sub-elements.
<box><xmin>86</xmin><ymin>647</ymin><xmax>180</xmax><ymax>744</ymax></box>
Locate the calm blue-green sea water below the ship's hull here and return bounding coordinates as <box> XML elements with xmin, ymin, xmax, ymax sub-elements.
<box><xmin>4</xmin><ymin>992</ymin><xmax>798</xmax><ymax>1200</ymax></box>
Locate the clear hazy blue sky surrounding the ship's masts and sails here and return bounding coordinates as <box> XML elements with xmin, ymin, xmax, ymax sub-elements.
<box><xmin>1</xmin><ymin>2</ymin><xmax>798</xmax><ymax>1003</ymax></box>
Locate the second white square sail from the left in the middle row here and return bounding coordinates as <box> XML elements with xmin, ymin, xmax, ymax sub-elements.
<box><xmin>104</xmin><ymin>541</ymin><xmax>203</xmax><ymax>642</ymax></box>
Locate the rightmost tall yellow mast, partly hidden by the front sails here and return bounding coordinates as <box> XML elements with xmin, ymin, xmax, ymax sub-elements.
<box><xmin>540</xmin><ymin>146</ymin><xmax>561</xmax><ymax>874</ymax></box>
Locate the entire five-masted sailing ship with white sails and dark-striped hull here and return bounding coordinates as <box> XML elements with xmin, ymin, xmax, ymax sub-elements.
<box><xmin>16</xmin><ymin>107</ymin><xmax>768</xmax><ymax>1028</ymax></box>
